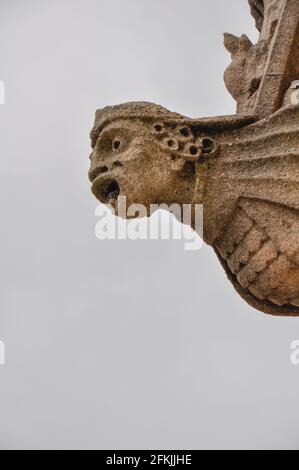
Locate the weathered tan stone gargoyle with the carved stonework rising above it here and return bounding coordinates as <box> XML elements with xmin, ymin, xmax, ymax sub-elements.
<box><xmin>89</xmin><ymin>0</ymin><xmax>299</xmax><ymax>316</ymax></box>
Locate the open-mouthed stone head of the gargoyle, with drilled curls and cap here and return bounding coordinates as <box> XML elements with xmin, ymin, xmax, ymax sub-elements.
<box><xmin>89</xmin><ymin>102</ymin><xmax>214</xmax><ymax>215</ymax></box>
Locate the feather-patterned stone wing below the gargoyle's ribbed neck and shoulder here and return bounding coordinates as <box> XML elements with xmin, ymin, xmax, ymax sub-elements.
<box><xmin>214</xmin><ymin>198</ymin><xmax>299</xmax><ymax>315</ymax></box>
